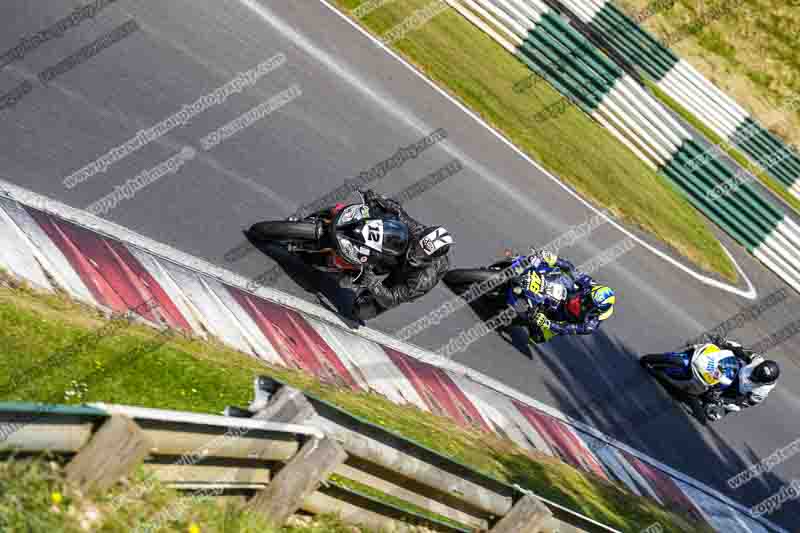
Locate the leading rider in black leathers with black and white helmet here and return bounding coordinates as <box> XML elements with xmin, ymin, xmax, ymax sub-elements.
<box><xmin>353</xmin><ymin>189</ymin><xmax>454</xmax><ymax>320</ymax></box>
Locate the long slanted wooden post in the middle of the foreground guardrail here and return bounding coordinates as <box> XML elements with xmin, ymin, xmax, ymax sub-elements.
<box><xmin>248</xmin><ymin>437</ymin><xmax>347</xmax><ymax>527</ymax></box>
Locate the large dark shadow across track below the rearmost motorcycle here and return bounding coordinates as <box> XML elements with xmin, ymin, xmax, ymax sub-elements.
<box><xmin>528</xmin><ymin>330</ymin><xmax>798</xmax><ymax>524</ymax></box>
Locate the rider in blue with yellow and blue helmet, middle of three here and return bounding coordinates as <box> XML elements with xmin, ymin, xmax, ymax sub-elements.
<box><xmin>514</xmin><ymin>250</ymin><xmax>616</xmax><ymax>343</ymax></box>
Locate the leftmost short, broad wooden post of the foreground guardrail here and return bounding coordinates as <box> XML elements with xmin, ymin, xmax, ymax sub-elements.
<box><xmin>66</xmin><ymin>415</ymin><xmax>152</xmax><ymax>491</ymax></box>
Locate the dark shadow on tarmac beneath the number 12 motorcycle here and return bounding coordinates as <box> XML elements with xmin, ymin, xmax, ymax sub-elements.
<box><xmin>239</xmin><ymin>232</ymin><xmax>363</xmax><ymax>328</ymax></box>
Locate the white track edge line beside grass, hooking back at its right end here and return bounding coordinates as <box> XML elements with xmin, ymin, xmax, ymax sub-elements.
<box><xmin>298</xmin><ymin>0</ymin><xmax>758</xmax><ymax>300</ymax></box>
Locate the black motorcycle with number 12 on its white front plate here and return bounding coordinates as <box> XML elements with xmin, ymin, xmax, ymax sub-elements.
<box><xmin>247</xmin><ymin>191</ymin><xmax>409</xmax><ymax>282</ymax></box>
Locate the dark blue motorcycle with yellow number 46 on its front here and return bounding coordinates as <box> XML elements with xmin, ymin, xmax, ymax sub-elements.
<box><xmin>444</xmin><ymin>248</ymin><xmax>580</xmax><ymax>344</ymax></box>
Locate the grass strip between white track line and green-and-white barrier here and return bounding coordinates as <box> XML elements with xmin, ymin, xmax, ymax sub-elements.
<box><xmin>328</xmin><ymin>0</ymin><xmax>737</xmax><ymax>281</ymax></box>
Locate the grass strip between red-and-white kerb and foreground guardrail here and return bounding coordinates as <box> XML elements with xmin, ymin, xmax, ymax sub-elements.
<box><xmin>0</xmin><ymin>276</ymin><xmax>712</xmax><ymax>533</ymax></box>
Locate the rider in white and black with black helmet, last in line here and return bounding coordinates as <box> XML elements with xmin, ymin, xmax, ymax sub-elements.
<box><xmin>707</xmin><ymin>336</ymin><xmax>780</xmax><ymax>420</ymax></box>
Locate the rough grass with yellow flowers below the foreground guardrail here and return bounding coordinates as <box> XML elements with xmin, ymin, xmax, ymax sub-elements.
<box><xmin>0</xmin><ymin>458</ymin><xmax>376</xmax><ymax>533</ymax></box>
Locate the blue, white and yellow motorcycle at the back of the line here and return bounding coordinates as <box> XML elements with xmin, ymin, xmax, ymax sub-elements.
<box><xmin>639</xmin><ymin>342</ymin><xmax>741</xmax><ymax>425</ymax></box>
